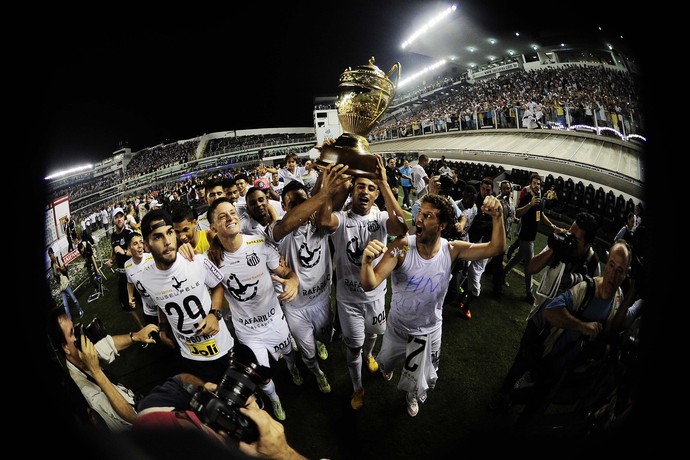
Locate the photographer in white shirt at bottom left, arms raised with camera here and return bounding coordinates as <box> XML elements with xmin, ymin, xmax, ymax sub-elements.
<box><xmin>47</xmin><ymin>308</ymin><xmax>158</xmax><ymax>431</ymax></box>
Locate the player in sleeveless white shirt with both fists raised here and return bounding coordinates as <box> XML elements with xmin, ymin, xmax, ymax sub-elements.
<box><xmin>361</xmin><ymin>194</ymin><xmax>505</xmax><ymax>417</ymax></box>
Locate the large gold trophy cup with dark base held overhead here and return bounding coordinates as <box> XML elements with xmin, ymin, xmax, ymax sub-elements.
<box><xmin>316</xmin><ymin>56</ymin><xmax>400</xmax><ymax>179</ymax></box>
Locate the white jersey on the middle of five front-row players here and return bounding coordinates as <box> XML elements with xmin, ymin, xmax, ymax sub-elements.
<box><xmin>266</xmin><ymin>222</ymin><xmax>333</xmax><ymax>309</ymax></box>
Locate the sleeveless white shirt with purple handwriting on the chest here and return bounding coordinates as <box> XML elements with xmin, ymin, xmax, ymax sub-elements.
<box><xmin>390</xmin><ymin>235</ymin><xmax>452</xmax><ymax>335</ymax></box>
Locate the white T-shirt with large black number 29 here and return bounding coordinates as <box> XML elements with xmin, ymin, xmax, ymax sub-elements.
<box><xmin>139</xmin><ymin>254</ymin><xmax>234</xmax><ymax>361</ymax></box>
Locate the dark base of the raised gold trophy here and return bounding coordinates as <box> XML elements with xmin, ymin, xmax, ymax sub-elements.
<box><xmin>315</xmin><ymin>133</ymin><xmax>379</xmax><ymax>180</ymax></box>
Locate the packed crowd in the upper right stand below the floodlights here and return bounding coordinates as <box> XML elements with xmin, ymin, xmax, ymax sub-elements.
<box><xmin>371</xmin><ymin>64</ymin><xmax>644</xmax><ymax>140</ymax></box>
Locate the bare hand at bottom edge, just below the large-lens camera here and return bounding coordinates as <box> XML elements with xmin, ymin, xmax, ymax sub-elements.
<box><xmin>239</xmin><ymin>396</ymin><xmax>306</xmax><ymax>460</ymax></box>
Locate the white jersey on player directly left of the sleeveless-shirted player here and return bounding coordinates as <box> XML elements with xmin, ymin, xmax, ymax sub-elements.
<box><xmin>331</xmin><ymin>207</ymin><xmax>388</xmax><ymax>302</ymax></box>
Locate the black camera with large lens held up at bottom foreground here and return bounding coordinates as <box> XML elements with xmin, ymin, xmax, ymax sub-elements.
<box><xmin>190</xmin><ymin>342</ymin><xmax>265</xmax><ymax>443</ymax></box>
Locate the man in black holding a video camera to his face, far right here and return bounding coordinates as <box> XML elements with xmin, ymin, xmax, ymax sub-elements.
<box><xmin>492</xmin><ymin>212</ymin><xmax>601</xmax><ymax>409</ymax></box>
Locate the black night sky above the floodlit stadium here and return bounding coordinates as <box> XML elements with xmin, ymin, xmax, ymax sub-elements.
<box><xmin>32</xmin><ymin>1</ymin><xmax>640</xmax><ymax>173</ymax></box>
